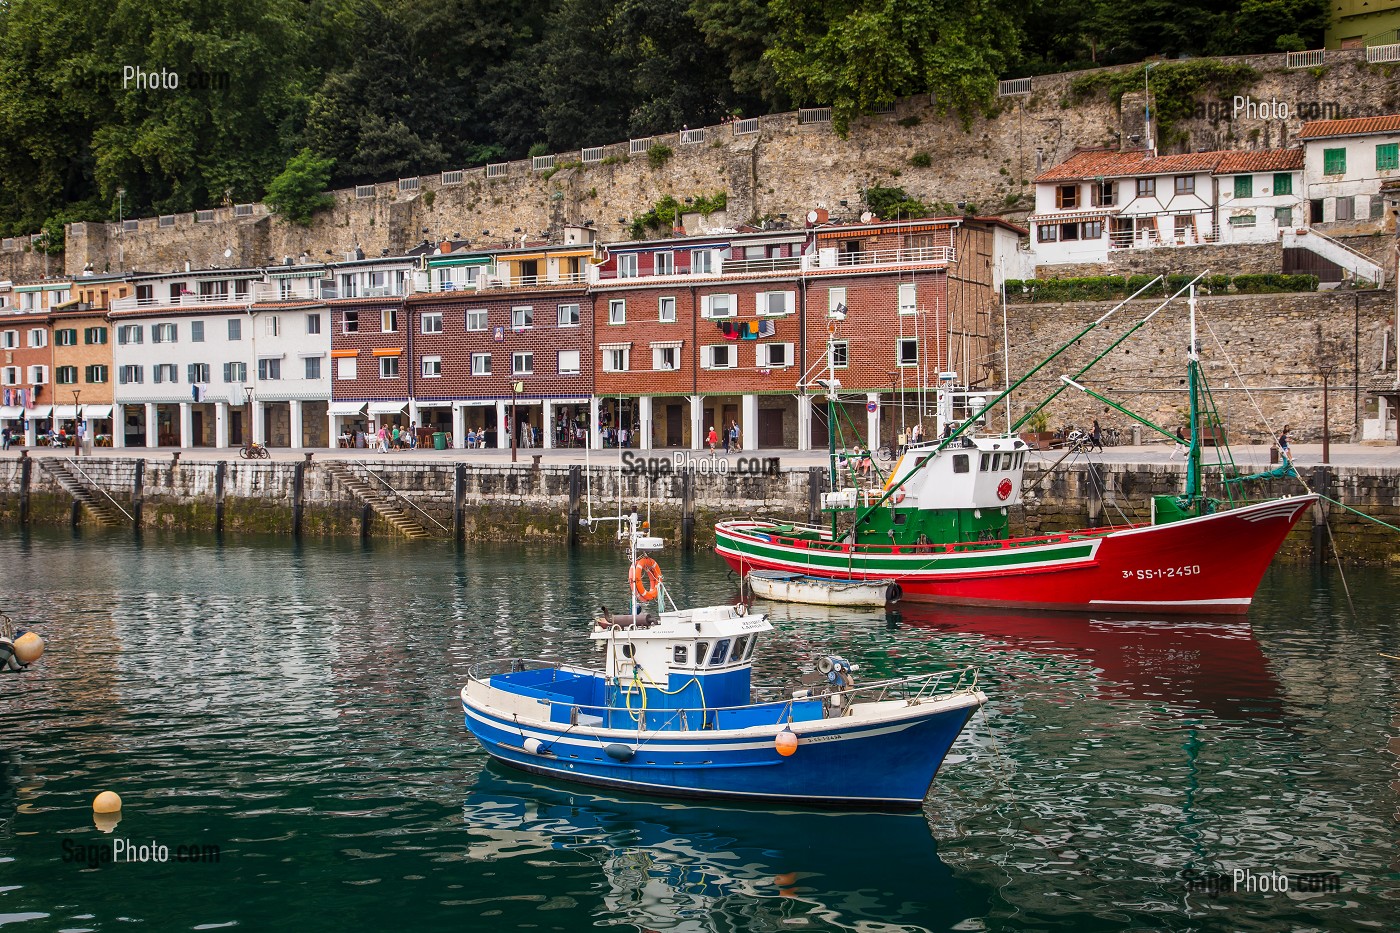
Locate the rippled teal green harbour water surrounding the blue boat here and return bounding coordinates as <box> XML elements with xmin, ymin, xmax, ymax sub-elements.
<box><xmin>0</xmin><ymin>532</ymin><xmax>1400</xmax><ymax>933</ymax></box>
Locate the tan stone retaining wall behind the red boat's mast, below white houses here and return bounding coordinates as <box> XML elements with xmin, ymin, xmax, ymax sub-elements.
<box><xmin>1007</xmin><ymin>291</ymin><xmax>1396</xmax><ymax>444</ymax></box>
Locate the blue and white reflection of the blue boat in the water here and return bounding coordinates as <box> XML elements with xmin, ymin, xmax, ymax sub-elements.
<box><xmin>462</xmin><ymin>763</ymin><xmax>990</xmax><ymax>930</ymax></box>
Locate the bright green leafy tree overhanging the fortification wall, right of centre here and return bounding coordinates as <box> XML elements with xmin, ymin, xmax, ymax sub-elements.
<box><xmin>763</xmin><ymin>0</ymin><xmax>1019</xmax><ymax>134</ymax></box>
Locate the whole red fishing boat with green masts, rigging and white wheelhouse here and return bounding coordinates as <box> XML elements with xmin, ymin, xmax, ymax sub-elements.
<box><xmin>715</xmin><ymin>275</ymin><xmax>1317</xmax><ymax>614</ymax></box>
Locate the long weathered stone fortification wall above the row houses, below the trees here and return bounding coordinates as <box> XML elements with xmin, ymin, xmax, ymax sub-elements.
<box><xmin>57</xmin><ymin>52</ymin><xmax>1400</xmax><ymax>275</ymax></box>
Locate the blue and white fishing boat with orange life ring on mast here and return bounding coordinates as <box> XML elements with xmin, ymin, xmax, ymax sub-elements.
<box><xmin>462</xmin><ymin>514</ymin><xmax>987</xmax><ymax>810</ymax></box>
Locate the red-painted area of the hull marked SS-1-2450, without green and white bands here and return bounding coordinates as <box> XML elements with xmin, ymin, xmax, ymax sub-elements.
<box><xmin>721</xmin><ymin>496</ymin><xmax>1316</xmax><ymax>615</ymax></box>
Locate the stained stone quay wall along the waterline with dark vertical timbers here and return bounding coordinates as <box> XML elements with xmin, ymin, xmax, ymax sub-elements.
<box><xmin>0</xmin><ymin>457</ymin><xmax>1400</xmax><ymax>563</ymax></box>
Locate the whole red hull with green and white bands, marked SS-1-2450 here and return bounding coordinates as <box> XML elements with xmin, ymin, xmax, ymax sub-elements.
<box><xmin>715</xmin><ymin>496</ymin><xmax>1317</xmax><ymax>615</ymax></box>
